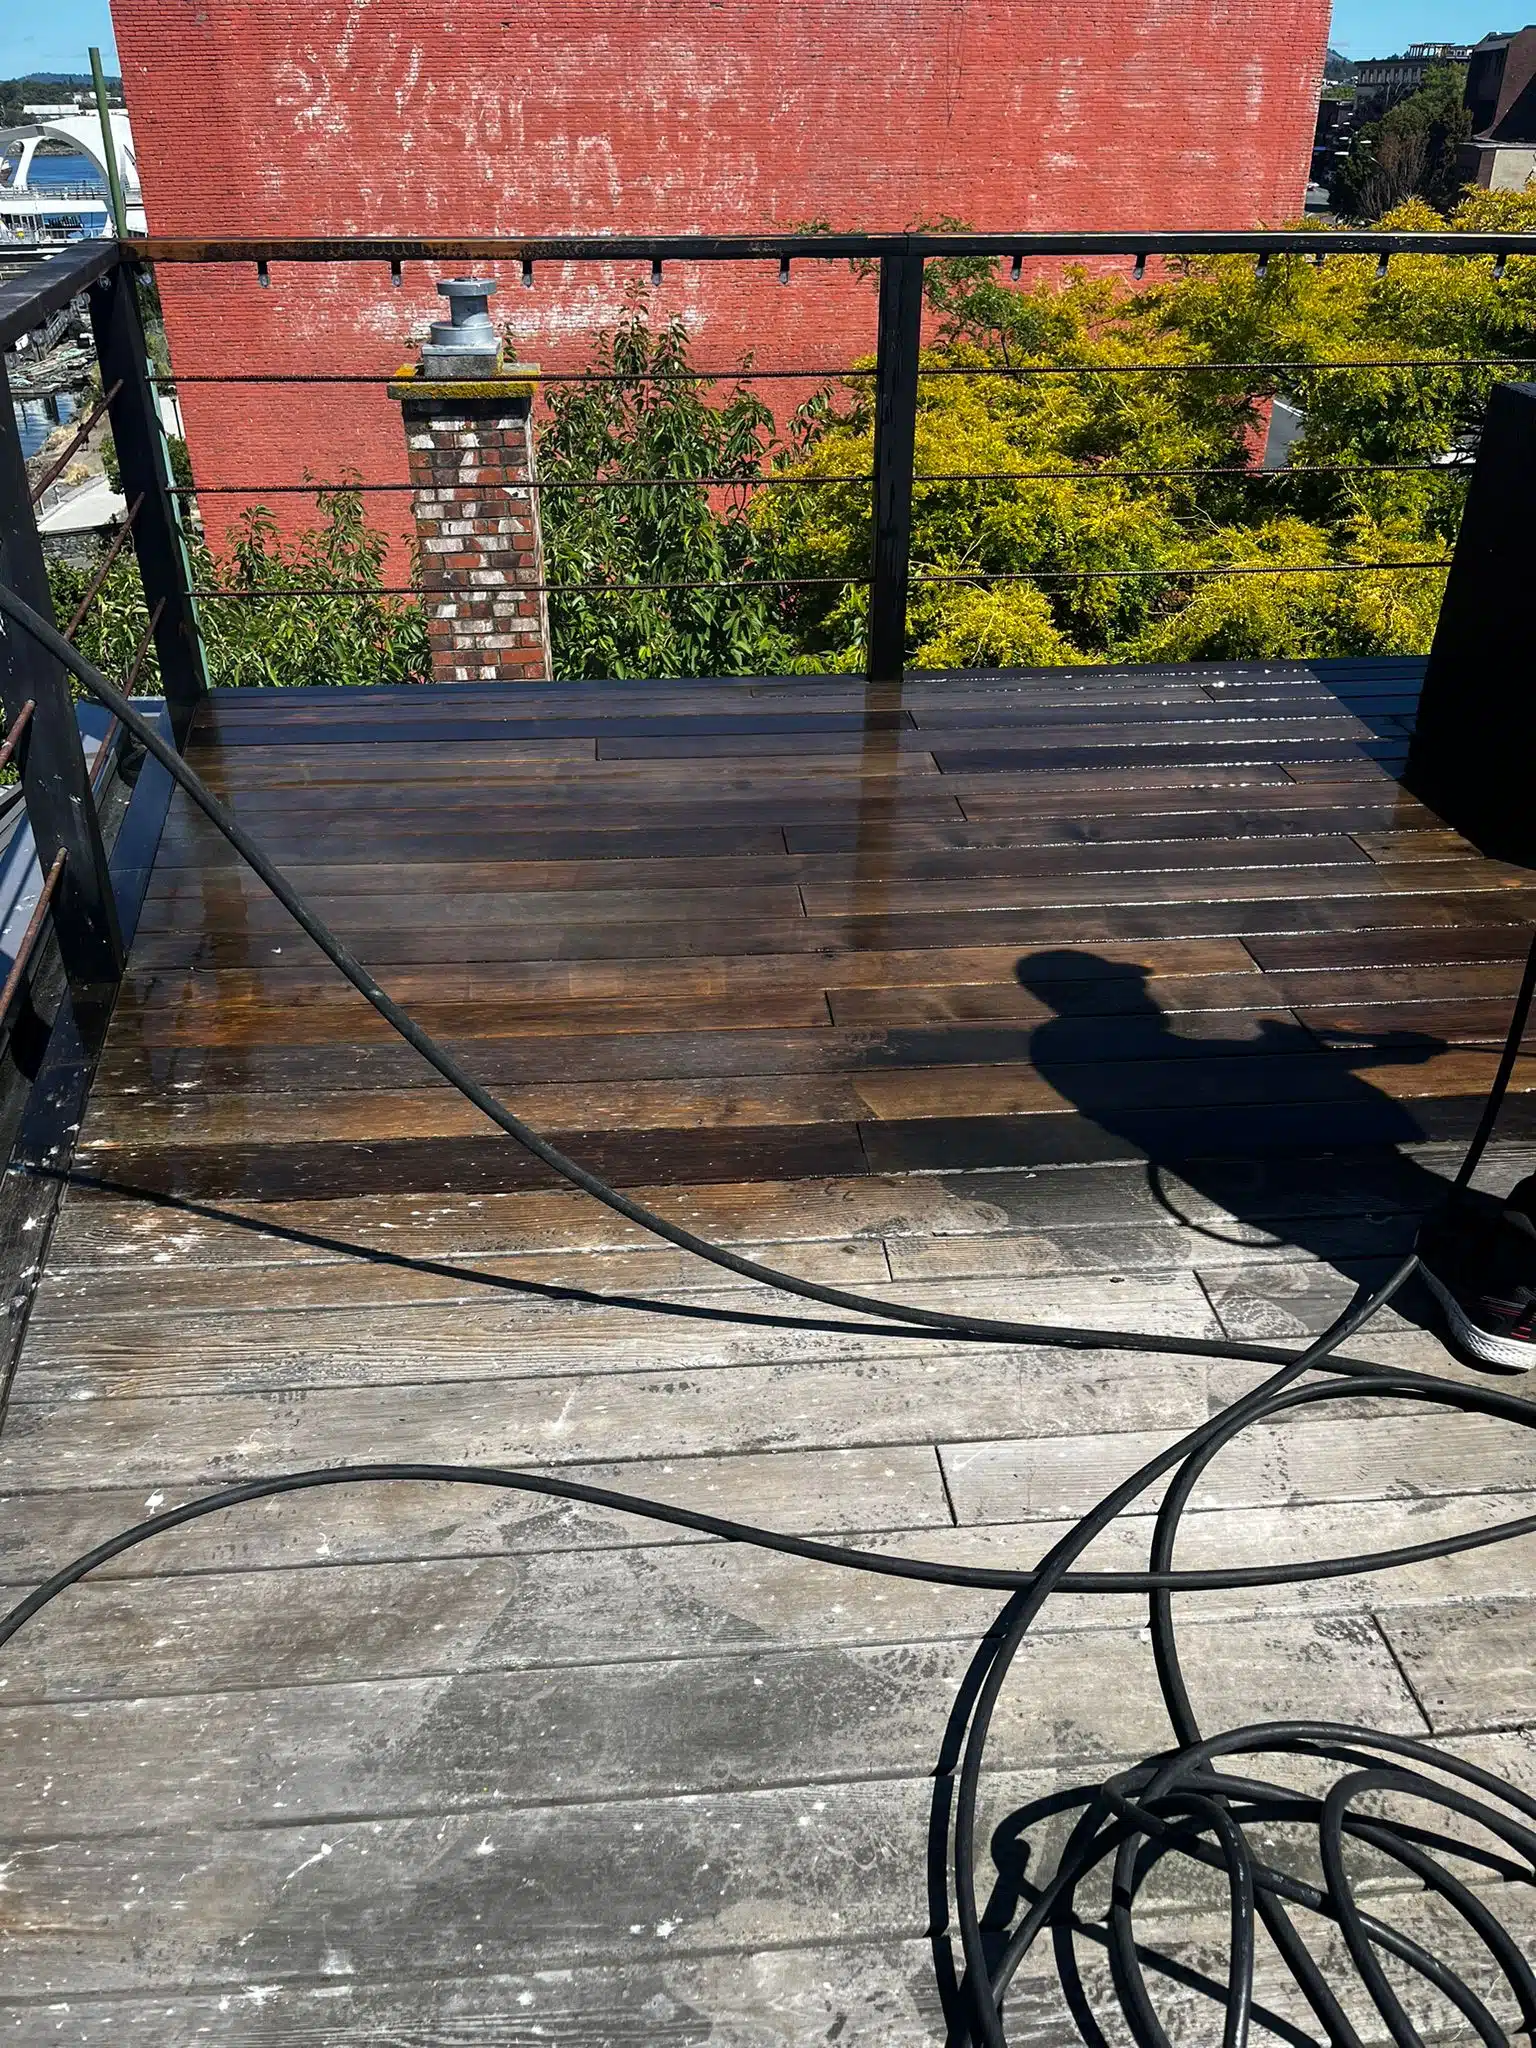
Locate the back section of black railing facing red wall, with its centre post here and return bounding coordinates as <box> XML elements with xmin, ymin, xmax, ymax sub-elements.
<box><xmin>131</xmin><ymin>229</ymin><xmax>1536</xmax><ymax>680</ymax></box>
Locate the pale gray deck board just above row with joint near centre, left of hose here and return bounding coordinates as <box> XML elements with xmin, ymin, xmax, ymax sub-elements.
<box><xmin>0</xmin><ymin>1339</ymin><xmax>1206</xmax><ymax>1489</ymax></box>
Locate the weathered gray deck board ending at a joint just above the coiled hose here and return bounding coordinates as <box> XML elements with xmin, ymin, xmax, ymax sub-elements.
<box><xmin>0</xmin><ymin>1614</ymin><xmax>1433</xmax><ymax>1841</ymax></box>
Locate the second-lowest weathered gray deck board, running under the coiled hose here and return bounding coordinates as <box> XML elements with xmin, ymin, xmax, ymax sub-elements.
<box><xmin>12</xmin><ymin>1739</ymin><xmax>1530</xmax><ymax>1997</ymax></box>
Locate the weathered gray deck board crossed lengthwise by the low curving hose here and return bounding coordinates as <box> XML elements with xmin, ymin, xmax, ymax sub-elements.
<box><xmin>0</xmin><ymin>1493</ymin><xmax>1536</xmax><ymax>1706</ymax></box>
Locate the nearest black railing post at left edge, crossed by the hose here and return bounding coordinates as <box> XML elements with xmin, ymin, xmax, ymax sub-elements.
<box><xmin>0</xmin><ymin>354</ymin><xmax>123</xmax><ymax>1001</ymax></box>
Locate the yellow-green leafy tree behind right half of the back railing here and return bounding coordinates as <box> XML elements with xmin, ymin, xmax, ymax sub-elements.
<box><xmin>754</xmin><ymin>193</ymin><xmax>1536</xmax><ymax>670</ymax></box>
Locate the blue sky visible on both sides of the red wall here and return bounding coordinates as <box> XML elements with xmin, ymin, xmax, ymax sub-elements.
<box><xmin>0</xmin><ymin>0</ymin><xmax>1536</xmax><ymax>78</ymax></box>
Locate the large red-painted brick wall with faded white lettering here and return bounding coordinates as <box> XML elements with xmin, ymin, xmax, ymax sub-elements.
<box><xmin>115</xmin><ymin>0</ymin><xmax>1329</xmax><ymax>552</ymax></box>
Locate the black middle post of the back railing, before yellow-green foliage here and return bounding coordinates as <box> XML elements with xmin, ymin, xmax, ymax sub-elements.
<box><xmin>868</xmin><ymin>250</ymin><xmax>924</xmax><ymax>682</ymax></box>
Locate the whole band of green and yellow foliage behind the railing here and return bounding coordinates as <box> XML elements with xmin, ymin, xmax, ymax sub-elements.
<box><xmin>53</xmin><ymin>193</ymin><xmax>1536</xmax><ymax>686</ymax></box>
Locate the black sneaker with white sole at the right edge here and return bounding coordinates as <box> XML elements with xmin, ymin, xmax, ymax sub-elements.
<box><xmin>1417</xmin><ymin>1180</ymin><xmax>1536</xmax><ymax>1372</ymax></box>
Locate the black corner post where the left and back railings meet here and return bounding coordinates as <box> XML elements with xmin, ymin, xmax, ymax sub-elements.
<box><xmin>90</xmin><ymin>262</ymin><xmax>209</xmax><ymax>745</ymax></box>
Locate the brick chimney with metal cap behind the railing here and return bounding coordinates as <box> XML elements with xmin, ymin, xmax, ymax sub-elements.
<box><xmin>389</xmin><ymin>279</ymin><xmax>553</xmax><ymax>682</ymax></box>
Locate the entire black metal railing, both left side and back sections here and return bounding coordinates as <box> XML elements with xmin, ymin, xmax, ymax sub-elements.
<box><xmin>0</xmin><ymin>229</ymin><xmax>1536</xmax><ymax>1007</ymax></box>
